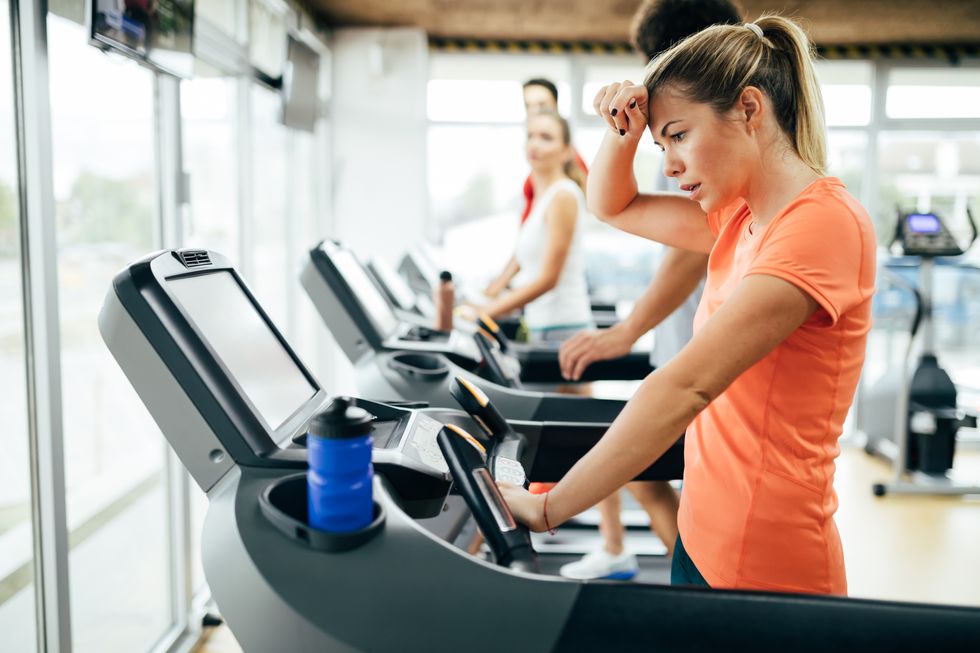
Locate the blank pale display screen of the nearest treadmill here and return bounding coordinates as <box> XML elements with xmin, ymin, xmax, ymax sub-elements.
<box><xmin>167</xmin><ymin>272</ymin><xmax>318</xmax><ymax>430</ymax></box>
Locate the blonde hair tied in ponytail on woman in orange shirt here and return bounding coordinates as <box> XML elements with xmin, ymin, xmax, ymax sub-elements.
<box><xmin>644</xmin><ymin>14</ymin><xmax>827</xmax><ymax>175</ymax></box>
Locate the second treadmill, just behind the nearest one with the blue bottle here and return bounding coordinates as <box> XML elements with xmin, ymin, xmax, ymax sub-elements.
<box><xmin>302</xmin><ymin>242</ymin><xmax>672</xmax><ymax>556</ymax></box>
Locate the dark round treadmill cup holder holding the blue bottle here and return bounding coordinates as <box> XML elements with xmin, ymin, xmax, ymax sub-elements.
<box><xmin>259</xmin><ymin>472</ymin><xmax>385</xmax><ymax>553</ymax></box>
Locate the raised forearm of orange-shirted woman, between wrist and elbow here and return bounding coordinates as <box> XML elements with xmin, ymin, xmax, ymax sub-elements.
<box><xmin>586</xmin><ymin>131</ymin><xmax>639</xmax><ymax>220</ymax></box>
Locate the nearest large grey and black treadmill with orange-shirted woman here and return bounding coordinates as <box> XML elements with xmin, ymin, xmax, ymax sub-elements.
<box><xmin>99</xmin><ymin>250</ymin><xmax>980</xmax><ymax>653</ymax></box>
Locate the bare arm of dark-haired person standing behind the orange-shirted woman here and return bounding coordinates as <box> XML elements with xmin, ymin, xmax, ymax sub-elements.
<box><xmin>558</xmin><ymin>248</ymin><xmax>708</xmax><ymax>381</ymax></box>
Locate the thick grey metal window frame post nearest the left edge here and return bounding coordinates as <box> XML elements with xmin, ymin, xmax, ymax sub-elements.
<box><xmin>10</xmin><ymin>0</ymin><xmax>72</xmax><ymax>653</ymax></box>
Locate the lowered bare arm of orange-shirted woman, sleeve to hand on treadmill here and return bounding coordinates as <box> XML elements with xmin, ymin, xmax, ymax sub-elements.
<box><xmin>500</xmin><ymin>275</ymin><xmax>817</xmax><ymax>531</ymax></box>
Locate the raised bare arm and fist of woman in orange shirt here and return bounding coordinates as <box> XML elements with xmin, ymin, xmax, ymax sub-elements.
<box><xmin>588</xmin><ymin>81</ymin><xmax>715</xmax><ymax>253</ymax></box>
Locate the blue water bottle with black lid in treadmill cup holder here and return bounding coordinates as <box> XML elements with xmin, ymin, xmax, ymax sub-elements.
<box><xmin>306</xmin><ymin>397</ymin><xmax>374</xmax><ymax>533</ymax></box>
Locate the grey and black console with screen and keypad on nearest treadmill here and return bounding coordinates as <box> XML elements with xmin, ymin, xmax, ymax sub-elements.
<box><xmin>99</xmin><ymin>250</ymin><xmax>472</xmax><ymax>502</ymax></box>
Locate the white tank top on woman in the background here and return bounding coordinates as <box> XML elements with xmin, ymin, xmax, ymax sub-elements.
<box><xmin>514</xmin><ymin>179</ymin><xmax>592</xmax><ymax>330</ymax></box>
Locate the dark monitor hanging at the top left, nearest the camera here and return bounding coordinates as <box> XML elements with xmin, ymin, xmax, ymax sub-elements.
<box><xmin>89</xmin><ymin>0</ymin><xmax>195</xmax><ymax>77</ymax></box>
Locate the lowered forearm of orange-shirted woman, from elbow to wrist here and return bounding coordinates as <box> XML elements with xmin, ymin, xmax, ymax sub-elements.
<box><xmin>548</xmin><ymin>367</ymin><xmax>708</xmax><ymax>525</ymax></box>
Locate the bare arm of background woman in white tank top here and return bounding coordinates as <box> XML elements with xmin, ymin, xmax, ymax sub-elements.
<box><xmin>483</xmin><ymin>191</ymin><xmax>578</xmax><ymax>317</ymax></box>
